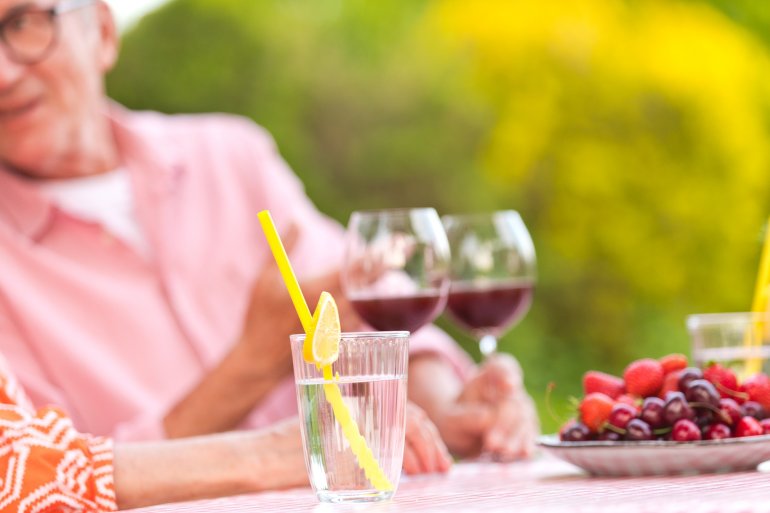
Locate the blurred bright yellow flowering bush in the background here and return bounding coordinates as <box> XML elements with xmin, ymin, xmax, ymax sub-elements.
<box><xmin>423</xmin><ymin>0</ymin><xmax>770</xmax><ymax>365</ymax></box>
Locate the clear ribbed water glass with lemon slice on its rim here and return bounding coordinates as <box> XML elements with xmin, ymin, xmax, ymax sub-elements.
<box><xmin>291</xmin><ymin>331</ymin><xmax>409</xmax><ymax>502</ymax></box>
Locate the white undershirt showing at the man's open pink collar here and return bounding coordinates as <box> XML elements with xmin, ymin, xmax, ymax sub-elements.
<box><xmin>37</xmin><ymin>168</ymin><xmax>150</xmax><ymax>257</ymax></box>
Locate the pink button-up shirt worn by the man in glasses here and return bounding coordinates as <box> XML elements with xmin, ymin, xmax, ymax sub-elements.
<box><xmin>0</xmin><ymin>106</ymin><xmax>470</xmax><ymax>440</ymax></box>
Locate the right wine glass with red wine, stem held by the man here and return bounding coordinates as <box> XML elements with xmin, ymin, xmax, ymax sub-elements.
<box><xmin>442</xmin><ymin>210</ymin><xmax>536</xmax><ymax>358</ymax></box>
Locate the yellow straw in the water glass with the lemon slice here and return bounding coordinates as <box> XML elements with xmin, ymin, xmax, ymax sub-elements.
<box><xmin>258</xmin><ymin>210</ymin><xmax>393</xmax><ymax>491</ymax></box>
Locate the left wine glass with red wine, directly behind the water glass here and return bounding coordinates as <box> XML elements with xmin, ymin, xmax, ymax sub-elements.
<box><xmin>342</xmin><ymin>208</ymin><xmax>449</xmax><ymax>332</ymax></box>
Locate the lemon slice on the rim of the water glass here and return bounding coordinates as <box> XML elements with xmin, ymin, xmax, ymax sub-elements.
<box><xmin>302</xmin><ymin>292</ymin><xmax>340</xmax><ymax>367</ymax></box>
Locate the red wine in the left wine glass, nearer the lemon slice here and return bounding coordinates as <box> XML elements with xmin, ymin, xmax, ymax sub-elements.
<box><xmin>350</xmin><ymin>291</ymin><xmax>444</xmax><ymax>333</ymax></box>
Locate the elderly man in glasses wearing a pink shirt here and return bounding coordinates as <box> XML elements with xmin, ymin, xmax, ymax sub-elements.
<box><xmin>0</xmin><ymin>0</ymin><xmax>536</xmax><ymax>504</ymax></box>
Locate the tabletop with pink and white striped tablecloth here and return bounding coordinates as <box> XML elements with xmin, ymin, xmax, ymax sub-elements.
<box><xmin>123</xmin><ymin>456</ymin><xmax>770</xmax><ymax>513</ymax></box>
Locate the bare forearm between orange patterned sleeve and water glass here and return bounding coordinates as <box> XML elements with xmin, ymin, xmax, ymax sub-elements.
<box><xmin>113</xmin><ymin>418</ymin><xmax>307</xmax><ymax>509</ymax></box>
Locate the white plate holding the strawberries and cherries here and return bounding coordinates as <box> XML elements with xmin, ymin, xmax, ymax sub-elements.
<box><xmin>538</xmin><ymin>435</ymin><xmax>770</xmax><ymax>476</ymax></box>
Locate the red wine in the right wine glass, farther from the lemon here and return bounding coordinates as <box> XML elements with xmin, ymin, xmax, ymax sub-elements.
<box><xmin>447</xmin><ymin>282</ymin><xmax>534</xmax><ymax>334</ymax></box>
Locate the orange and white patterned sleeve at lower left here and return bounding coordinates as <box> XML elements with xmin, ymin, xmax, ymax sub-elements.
<box><xmin>0</xmin><ymin>357</ymin><xmax>117</xmax><ymax>513</ymax></box>
